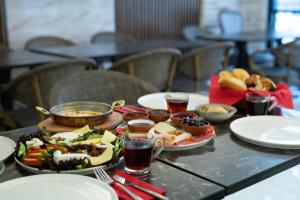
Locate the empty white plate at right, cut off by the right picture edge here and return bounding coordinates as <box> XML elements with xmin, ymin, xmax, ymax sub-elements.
<box><xmin>230</xmin><ymin>116</ymin><xmax>300</xmax><ymax>149</ymax></box>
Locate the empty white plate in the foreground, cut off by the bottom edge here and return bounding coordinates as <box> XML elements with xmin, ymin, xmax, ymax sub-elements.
<box><xmin>0</xmin><ymin>174</ymin><xmax>118</xmax><ymax>200</ymax></box>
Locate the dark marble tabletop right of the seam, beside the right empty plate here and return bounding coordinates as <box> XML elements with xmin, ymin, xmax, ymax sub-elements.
<box><xmin>159</xmin><ymin>118</ymin><xmax>300</xmax><ymax>194</ymax></box>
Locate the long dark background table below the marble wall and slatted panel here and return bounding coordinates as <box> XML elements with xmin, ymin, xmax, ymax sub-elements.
<box><xmin>32</xmin><ymin>40</ymin><xmax>200</xmax><ymax>59</ymax></box>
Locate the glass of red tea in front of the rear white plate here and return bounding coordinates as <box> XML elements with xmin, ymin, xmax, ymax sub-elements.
<box><xmin>165</xmin><ymin>92</ymin><xmax>189</xmax><ymax>113</ymax></box>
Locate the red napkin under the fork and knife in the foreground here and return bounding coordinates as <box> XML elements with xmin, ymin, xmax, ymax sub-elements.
<box><xmin>112</xmin><ymin>170</ymin><xmax>166</xmax><ymax>200</ymax></box>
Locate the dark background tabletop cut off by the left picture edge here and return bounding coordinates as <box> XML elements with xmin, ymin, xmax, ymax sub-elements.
<box><xmin>0</xmin><ymin>50</ymin><xmax>63</xmax><ymax>70</ymax></box>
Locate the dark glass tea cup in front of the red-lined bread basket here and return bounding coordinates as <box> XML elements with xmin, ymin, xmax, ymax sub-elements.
<box><xmin>246</xmin><ymin>93</ymin><xmax>277</xmax><ymax>116</ymax></box>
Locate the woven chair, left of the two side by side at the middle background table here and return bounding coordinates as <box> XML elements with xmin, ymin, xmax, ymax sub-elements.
<box><xmin>109</xmin><ymin>48</ymin><xmax>181</xmax><ymax>91</ymax></box>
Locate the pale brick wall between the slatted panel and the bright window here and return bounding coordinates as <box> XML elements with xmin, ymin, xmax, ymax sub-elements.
<box><xmin>200</xmin><ymin>0</ymin><xmax>268</xmax><ymax>31</ymax></box>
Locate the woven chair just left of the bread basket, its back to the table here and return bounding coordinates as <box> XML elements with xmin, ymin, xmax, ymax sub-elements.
<box><xmin>172</xmin><ymin>42</ymin><xmax>233</xmax><ymax>92</ymax></box>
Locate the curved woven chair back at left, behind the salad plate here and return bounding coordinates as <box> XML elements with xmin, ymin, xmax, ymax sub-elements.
<box><xmin>5</xmin><ymin>59</ymin><xmax>96</xmax><ymax>126</ymax></box>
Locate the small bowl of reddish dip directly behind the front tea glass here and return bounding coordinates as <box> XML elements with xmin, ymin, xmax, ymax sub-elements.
<box><xmin>127</xmin><ymin>119</ymin><xmax>155</xmax><ymax>132</ymax></box>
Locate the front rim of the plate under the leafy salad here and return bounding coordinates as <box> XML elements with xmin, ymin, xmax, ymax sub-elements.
<box><xmin>15</xmin><ymin>157</ymin><xmax>124</xmax><ymax>175</ymax></box>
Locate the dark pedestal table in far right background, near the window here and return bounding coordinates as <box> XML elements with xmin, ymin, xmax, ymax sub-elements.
<box><xmin>197</xmin><ymin>31</ymin><xmax>296</xmax><ymax>68</ymax></box>
